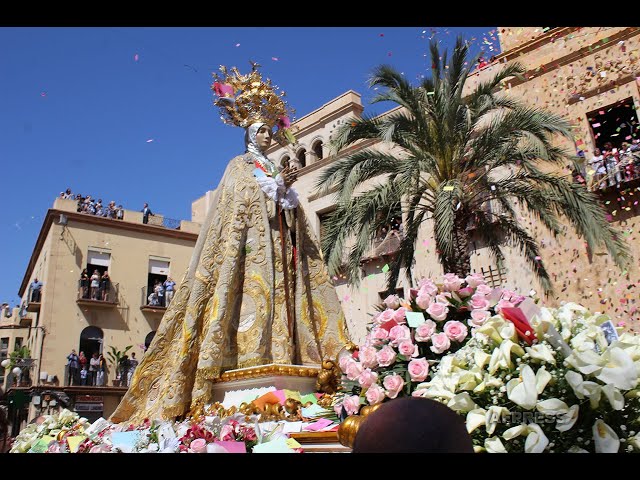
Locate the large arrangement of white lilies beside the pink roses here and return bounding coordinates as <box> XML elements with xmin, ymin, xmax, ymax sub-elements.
<box><xmin>412</xmin><ymin>303</ymin><xmax>640</xmax><ymax>453</ymax></box>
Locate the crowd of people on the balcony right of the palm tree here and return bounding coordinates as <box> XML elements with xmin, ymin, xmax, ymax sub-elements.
<box><xmin>587</xmin><ymin>140</ymin><xmax>640</xmax><ymax>190</ymax></box>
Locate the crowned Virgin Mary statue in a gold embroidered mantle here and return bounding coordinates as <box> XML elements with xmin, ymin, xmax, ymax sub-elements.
<box><xmin>111</xmin><ymin>66</ymin><xmax>349</xmax><ymax>422</ymax></box>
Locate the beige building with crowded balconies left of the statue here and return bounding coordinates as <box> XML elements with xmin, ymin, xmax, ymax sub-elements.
<box><xmin>0</xmin><ymin>199</ymin><xmax>200</xmax><ymax>430</ymax></box>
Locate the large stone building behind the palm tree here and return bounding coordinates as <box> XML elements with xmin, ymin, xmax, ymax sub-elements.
<box><xmin>268</xmin><ymin>27</ymin><xmax>640</xmax><ymax>340</ymax></box>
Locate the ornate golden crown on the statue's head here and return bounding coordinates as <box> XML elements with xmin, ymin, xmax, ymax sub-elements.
<box><xmin>211</xmin><ymin>62</ymin><xmax>295</xmax><ymax>141</ymax></box>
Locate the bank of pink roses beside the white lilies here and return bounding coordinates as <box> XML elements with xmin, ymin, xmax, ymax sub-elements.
<box><xmin>334</xmin><ymin>273</ymin><xmax>525</xmax><ymax>415</ymax></box>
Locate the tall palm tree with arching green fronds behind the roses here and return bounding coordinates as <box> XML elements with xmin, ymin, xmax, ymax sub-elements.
<box><xmin>315</xmin><ymin>37</ymin><xmax>629</xmax><ymax>293</ymax></box>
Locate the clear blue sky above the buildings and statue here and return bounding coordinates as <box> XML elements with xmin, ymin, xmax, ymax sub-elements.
<box><xmin>0</xmin><ymin>26</ymin><xmax>500</xmax><ymax>305</ymax></box>
